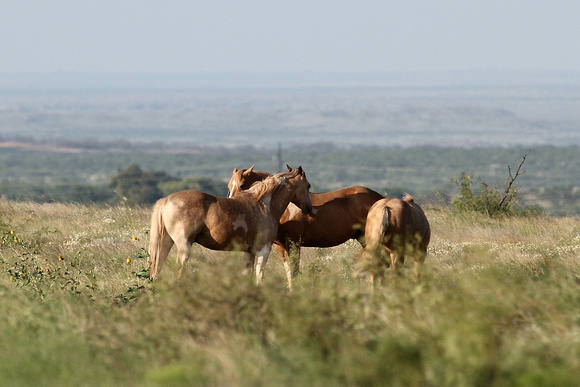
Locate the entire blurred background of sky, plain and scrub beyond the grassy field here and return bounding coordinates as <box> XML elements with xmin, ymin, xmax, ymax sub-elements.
<box><xmin>0</xmin><ymin>0</ymin><xmax>580</xmax><ymax>215</ymax></box>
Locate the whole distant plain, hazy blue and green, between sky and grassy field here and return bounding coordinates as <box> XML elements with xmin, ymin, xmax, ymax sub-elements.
<box><xmin>0</xmin><ymin>73</ymin><xmax>580</xmax><ymax>213</ymax></box>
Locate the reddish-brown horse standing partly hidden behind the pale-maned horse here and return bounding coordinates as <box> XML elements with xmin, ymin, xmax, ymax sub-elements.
<box><xmin>228</xmin><ymin>165</ymin><xmax>383</xmax><ymax>281</ymax></box>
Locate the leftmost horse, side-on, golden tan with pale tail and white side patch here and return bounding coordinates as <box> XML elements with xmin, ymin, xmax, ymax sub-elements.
<box><xmin>149</xmin><ymin>167</ymin><xmax>312</xmax><ymax>285</ymax></box>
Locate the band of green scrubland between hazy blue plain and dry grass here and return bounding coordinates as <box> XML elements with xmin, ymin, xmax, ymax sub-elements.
<box><xmin>0</xmin><ymin>144</ymin><xmax>580</xmax><ymax>215</ymax></box>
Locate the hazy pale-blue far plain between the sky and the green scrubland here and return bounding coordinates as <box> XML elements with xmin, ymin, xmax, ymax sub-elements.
<box><xmin>0</xmin><ymin>73</ymin><xmax>580</xmax><ymax>148</ymax></box>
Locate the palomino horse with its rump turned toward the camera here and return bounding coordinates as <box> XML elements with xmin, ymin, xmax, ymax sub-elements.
<box><xmin>361</xmin><ymin>195</ymin><xmax>431</xmax><ymax>282</ymax></box>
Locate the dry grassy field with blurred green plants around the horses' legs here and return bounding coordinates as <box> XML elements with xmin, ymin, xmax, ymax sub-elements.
<box><xmin>0</xmin><ymin>202</ymin><xmax>580</xmax><ymax>386</ymax></box>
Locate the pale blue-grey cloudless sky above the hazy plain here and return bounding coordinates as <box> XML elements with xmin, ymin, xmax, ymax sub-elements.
<box><xmin>0</xmin><ymin>0</ymin><xmax>580</xmax><ymax>73</ymax></box>
